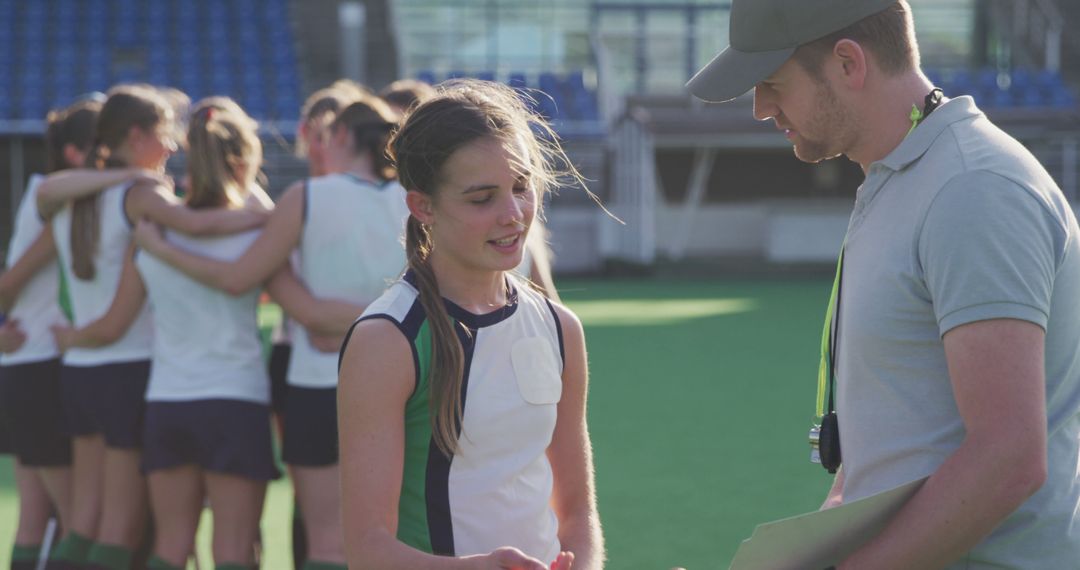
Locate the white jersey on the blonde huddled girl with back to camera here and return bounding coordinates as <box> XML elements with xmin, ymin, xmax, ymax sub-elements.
<box><xmin>135</xmin><ymin>230</ymin><xmax>270</xmax><ymax>404</ymax></box>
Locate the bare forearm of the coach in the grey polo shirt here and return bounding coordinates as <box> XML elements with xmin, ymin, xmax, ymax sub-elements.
<box><xmin>838</xmin><ymin>435</ymin><xmax>1047</xmax><ymax>570</ymax></box>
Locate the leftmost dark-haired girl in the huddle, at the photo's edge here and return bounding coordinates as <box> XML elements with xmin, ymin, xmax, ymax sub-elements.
<box><xmin>0</xmin><ymin>100</ymin><xmax>102</xmax><ymax>569</ymax></box>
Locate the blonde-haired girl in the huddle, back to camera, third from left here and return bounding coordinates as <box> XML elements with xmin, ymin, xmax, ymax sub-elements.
<box><xmin>136</xmin><ymin>99</ymin><xmax>278</xmax><ymax>570</ymax></box>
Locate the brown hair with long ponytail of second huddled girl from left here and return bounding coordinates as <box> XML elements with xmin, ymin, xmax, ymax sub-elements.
<box><xmin>71</xmin><ymin>85</ymin><xmax>173</xmax><ymax>281</ymax></box>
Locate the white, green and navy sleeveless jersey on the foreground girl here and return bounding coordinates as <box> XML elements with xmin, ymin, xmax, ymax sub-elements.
<box><xmin>361</xmin><ymin>273</ymin><xmax>564</xmax><ymax>560</ymax></box>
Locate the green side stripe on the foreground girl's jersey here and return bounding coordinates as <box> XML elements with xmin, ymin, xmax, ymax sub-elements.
<box><xmin>397</xmin><ymin>320</ymin><xmax>433</xmax><ymax>554</ymax></box>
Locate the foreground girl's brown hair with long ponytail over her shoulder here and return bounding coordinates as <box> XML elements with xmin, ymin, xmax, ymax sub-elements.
<box><xmin>389</xmin><ymin>80</ymin><xmax>591</xmax><ymax>456</ymax></box>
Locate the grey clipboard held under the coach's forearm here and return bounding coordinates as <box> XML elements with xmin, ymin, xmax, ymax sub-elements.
<box><xmin>729</xmin><ymin>477</ymin><xmax>927</xmax><ymax>570</ymax></box>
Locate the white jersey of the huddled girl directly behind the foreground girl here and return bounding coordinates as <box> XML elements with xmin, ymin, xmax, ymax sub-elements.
<box><xmin>286</xmin><ymin>174</ymin><xmax>408</xmax><ymax>388</ymax></box>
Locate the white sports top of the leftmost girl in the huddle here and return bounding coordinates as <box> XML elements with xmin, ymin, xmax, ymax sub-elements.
<box><xmin>0</xmin><ymin>174</ymin><xmax>67</xmax><ymax>366</ymax></box>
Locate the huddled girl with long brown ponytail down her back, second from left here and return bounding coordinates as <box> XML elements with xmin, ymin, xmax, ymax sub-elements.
<box><xmin>37</xmin><ymin>86</ymin><xmax>265</xmax><ymax>569</ymax></box>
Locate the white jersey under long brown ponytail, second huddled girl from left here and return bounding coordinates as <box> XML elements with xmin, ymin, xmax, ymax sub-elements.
<box><xmin>52</xmin><ymin>184</ymin><xmax>153</xmax><ymax>366</ymax></box>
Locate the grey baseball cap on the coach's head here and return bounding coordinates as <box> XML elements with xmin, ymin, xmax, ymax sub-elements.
<box><xmin>686</xmin><ymin>0</ymin><xmax>896</xmax><ymax>101</ymax></box>
